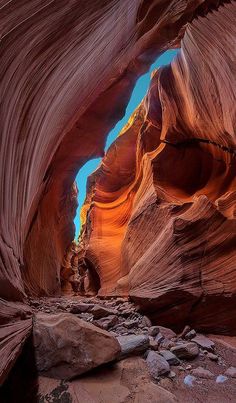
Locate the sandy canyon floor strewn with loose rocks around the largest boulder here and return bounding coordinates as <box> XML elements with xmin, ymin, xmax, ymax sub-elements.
<box><xmin>1</xmin><ymin>297</ymin><xmax>236</xmax><ymax>403</ymax></box>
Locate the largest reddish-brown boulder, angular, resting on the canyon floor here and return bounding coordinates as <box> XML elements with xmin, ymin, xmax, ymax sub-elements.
<box><xmin>33</xmin><ymin>313</ymin><xmax>120</xmax><ymax>379</ymax></box>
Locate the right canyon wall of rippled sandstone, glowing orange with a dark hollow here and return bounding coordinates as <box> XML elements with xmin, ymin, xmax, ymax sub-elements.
<box><xmin>82</xmin><ymin>2</ymin><xmax>236</xmax><ymax>334</ymax></box>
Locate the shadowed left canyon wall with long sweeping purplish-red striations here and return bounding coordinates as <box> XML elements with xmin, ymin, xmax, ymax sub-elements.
<box><xmin>0</xmin><ymin>0</ymin><xmax>215</xmax><ymax>382</ymax></box>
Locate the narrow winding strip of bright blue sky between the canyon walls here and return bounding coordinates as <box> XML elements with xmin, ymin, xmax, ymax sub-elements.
<box><xmin>74</xmin><ymin>50</ymin><xmax>177</xmax><ymax>239</ymax></box>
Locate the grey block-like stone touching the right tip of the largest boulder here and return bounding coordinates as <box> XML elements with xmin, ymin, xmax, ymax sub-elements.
<box><xmin>117</xmin><ymin>335</ymin><xmax>149</xmax><ymax>358</ymax></box>
